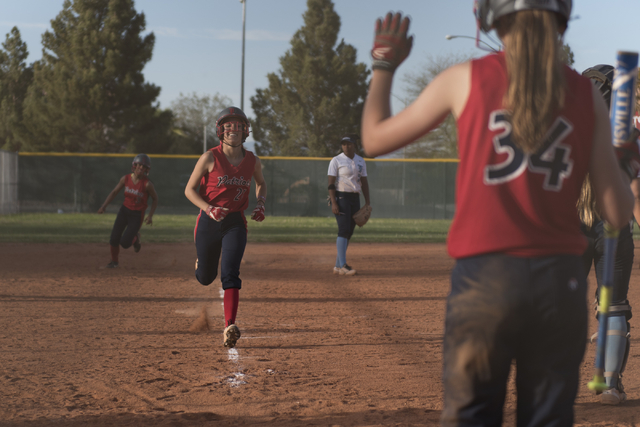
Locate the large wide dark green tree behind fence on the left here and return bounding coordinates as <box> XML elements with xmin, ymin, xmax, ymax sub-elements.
<box><xmin>23</xmin><ymin>0</ymin><xmax>171</xmax><ymax>153</ymax></box>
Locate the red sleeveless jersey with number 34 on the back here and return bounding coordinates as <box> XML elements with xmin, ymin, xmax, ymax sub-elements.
<box><xmin>448</xmin><ymin>52</ymin><xmax>595</xmax><ymax>258</ymax></box>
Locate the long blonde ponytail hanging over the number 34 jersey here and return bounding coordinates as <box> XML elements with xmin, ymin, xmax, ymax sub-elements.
<box><xmin>496</xmin><ymin>10</ymin><xmax>565</xmax><ymax>153</ymax></box>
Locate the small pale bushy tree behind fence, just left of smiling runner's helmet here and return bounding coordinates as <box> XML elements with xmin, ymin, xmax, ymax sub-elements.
<box><xmin>170</xmin><ymin>92</ymin><xmax>231</xmax><ymax>154</ymax></box>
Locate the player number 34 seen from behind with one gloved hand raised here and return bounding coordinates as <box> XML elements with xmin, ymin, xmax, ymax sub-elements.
<box><xmin>362</xmin><ymin>0</ymin><xmax>639</xmax><ymax>426</ymax></box>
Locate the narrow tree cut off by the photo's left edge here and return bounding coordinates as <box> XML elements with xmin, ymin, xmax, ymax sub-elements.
<box><xmin>0</xmin><ymin>27</ymin><xmax>33</xmax><ymax>151</ymax></box>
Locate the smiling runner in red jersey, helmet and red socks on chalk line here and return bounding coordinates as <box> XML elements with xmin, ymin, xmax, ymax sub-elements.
<box><xmin>184</xmin><ymin>107</ymin><xmax>267</xmax><ymax>347</ymax></box>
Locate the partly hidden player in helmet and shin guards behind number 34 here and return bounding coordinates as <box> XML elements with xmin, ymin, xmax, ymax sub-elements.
<box><xmin>578</xmin><ymin>64</ymin><xmax>640</xmax><ymax>405</ymax></box>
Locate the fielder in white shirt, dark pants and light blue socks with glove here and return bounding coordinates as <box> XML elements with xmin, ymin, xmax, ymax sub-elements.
<box><xmin>327</xmin><ymin>134</ymin><xmax>370</xmax><ymax>276</ymax></box>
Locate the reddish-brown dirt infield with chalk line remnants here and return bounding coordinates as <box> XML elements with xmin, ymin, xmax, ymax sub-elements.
<box><xmin>0</xmin><ymin>243</ymin><xmax>640</xmax><ymax>427</ymax></box>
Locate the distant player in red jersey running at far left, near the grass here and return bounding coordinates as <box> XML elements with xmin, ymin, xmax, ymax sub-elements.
<box><xmin>98</xmin><ymin>154</ymin><xmax>158</xmax><ymax>268</ymax></box>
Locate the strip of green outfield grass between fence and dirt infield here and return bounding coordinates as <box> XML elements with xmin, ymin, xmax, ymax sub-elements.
<box><xmin>0</xmin><ymin>213</ymin><xmax>451</xmax><ymax>243</ymax></box>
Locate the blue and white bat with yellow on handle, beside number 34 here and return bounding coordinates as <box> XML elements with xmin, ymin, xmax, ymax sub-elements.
<box><xmin>588</xmin><ymin>51</ymin><xmax>638</xmax><ymax>393</ymax></box>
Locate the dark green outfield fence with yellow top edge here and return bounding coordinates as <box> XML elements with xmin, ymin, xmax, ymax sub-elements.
<box><xmin>11</xmin><ymin>153</ymin><xmax>458</xmax><ymax>219</ymax></box>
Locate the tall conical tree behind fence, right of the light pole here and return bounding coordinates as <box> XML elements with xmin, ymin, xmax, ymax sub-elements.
<box><xmin>251</xmin><ymin>0</ymin><xmax>369</xmax><ymax>157</ymax></box>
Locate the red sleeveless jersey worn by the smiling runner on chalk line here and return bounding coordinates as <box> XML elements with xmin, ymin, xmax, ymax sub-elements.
<box><xmin>199</xmin><ymin>144</ymin><xmax>256</xmax><ymax>213</ymax></box>
